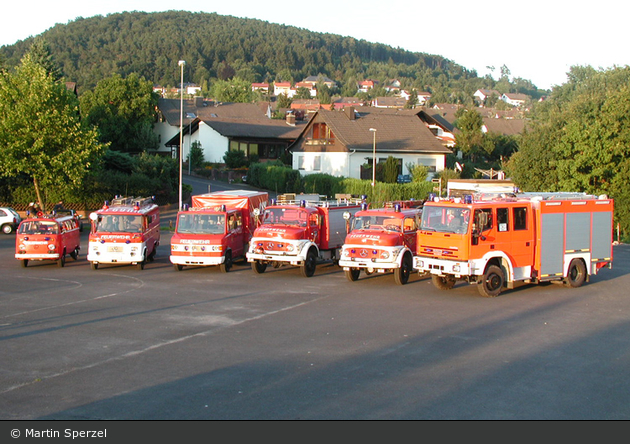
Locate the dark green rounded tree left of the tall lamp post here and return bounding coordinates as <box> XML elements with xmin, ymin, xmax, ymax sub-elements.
<box><xmin>80</xmin><ymin>74</ymin><xmax>159</xmax><ymax>154</ymax></box>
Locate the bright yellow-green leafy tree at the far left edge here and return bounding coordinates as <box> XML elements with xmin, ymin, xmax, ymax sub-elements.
<box><xmin>0</xmin><ymin>54</ymin><xmax>106</xmax><ymax>211</ymax></box>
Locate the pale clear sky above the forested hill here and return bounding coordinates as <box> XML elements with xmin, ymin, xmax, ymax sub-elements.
<box><xmin>0</xmin><ymin>0</ymin><xmax>630</xmax><ymax>89</ymax></box>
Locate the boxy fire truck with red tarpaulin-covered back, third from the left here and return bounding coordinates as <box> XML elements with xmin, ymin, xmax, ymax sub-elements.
<box><xmin>170</xmin><ymin>190</ymin><xmax>269</xmax><ymax>272</ymax></box>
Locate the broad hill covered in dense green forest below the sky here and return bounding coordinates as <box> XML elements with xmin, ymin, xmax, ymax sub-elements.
<box><xmin>0</xmin><ymin>11</ymin><xmax>541</xmax><ymax>101</ymax></box>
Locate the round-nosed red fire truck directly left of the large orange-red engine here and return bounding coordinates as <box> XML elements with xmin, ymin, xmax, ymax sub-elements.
<box><xmin>339</xmin><ymin>201</ymin><xmax>422</xmax><ymax>285</ymax></box>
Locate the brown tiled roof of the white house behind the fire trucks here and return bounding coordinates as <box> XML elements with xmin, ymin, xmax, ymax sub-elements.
<box><xmin>294</xmin><ymin>107</ymin><xmax>451</xmax><ymax>154</ymax></box>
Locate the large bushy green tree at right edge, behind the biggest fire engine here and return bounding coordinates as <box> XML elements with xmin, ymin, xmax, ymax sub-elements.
<box><xmin>506</xmin><ymin>67</ymin><xmax>630</xmax><ymax>232</ymax></box>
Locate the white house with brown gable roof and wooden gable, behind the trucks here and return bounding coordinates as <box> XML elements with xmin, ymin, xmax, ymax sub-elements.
<box><xmin>289</xmin><ymin>106</ymin><xmax>451</xmax><ymax>179</ymax></box>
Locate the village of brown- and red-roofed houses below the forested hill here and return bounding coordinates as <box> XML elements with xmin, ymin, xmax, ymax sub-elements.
<box><xmin>154</xmin><ymin>75</ymin><xmax>531</xmax><ymax>178</ymax></box>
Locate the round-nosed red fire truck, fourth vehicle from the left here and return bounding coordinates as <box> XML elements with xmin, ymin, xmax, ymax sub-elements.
<box><xmin>247</xmin><ymin>195</ymin><xmax>360</xmax><ymax>277</ymax></box>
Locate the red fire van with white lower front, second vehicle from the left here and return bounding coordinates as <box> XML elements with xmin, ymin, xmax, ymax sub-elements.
<box><xmin>87</xmin><ymin>197</ymin><xmax>160</xmax><ymax>270</ymax></box>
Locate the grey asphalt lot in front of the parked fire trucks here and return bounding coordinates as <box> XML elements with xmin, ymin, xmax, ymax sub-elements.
<box><xmin>0</xmin><ymin>176</ymin><xmax>630</xmax><ymax>420</ymax></box>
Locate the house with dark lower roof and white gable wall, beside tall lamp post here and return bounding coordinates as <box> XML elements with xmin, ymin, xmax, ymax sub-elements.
<box><xmin>154</xmin><ymin>97</ymin><xmax>305</xmax><ymax>163</ymax></box>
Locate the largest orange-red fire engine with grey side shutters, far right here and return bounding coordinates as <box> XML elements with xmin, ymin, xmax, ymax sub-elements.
<box><xmin>414</xmin><ymin>193</ymin><xmax>614</xmax><ymax>297</ymax></box>
